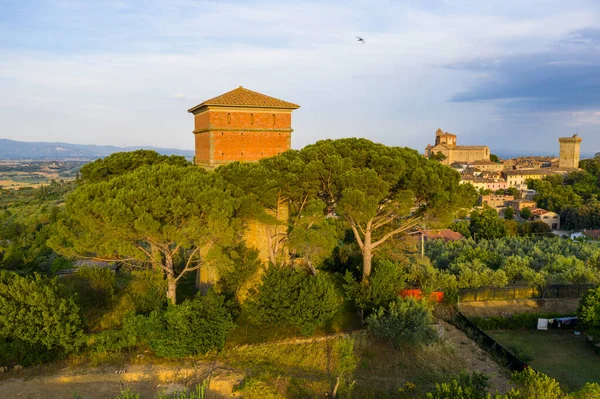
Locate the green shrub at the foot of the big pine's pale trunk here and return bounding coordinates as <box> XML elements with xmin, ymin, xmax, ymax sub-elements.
<box><xmin>344</xmin><ymin>261</ymin><xmax>405</xmax><ymax>313</ymax></box>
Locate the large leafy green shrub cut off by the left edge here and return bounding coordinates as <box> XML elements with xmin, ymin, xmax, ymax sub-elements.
<box><xmin>0</xmin><ymin>271</ymin><xmax>83</xmax><ymax>360</ymax></box>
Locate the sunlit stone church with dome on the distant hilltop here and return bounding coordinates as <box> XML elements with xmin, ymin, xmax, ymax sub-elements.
<box><xmin>425</xmin><ymin>129</ymin><xmax>490</xmax><ymax>165</ymax></box>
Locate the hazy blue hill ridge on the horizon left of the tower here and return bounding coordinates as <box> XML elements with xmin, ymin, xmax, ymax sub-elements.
<box><xmin>0</xmin><ymin>139</ymin><xmax>194</xmax><ymax>160</ymax></box>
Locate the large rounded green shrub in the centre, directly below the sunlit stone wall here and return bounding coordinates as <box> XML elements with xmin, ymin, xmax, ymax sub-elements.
<box><xmin>248</xmin><ymin>267</ymin><xmax>340</xmax><ymax>335</ymax></box>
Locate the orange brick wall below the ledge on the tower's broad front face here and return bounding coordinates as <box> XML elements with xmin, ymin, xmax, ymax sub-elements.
<box><xmin>212</xmin><ymin>131</ymin><xmax>291</xmax><ymax>163</ymax></box>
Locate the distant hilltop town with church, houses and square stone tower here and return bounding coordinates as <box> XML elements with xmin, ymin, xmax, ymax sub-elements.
<box><xmin>424</xmin><ymin>129</ymin><xmax>584</xmax><ymax>230</ymax></box>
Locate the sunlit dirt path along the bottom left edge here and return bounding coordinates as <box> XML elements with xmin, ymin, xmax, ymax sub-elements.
<box><xmin>0</xmin><ymin>363</ymin><xmax>242</xmax><ymax>399</ymax></box>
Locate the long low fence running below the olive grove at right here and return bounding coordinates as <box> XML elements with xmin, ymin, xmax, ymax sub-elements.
<box><xmin>459</xmin><ymin>284</ymin><xmax>594</xmax><ymax>302</ymax></box>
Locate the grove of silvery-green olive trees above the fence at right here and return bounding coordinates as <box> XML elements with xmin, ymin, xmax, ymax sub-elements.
<box><xmin>425</xmin><ymin>237</ymin><xmax>600</xmax><ymax>291</ymax></box>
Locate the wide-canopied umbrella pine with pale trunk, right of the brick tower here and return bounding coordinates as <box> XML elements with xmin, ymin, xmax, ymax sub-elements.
<box><xmin>217</xmin><ymin>139</ymin><xmax>476</xmax><ymax>279</ymax></box>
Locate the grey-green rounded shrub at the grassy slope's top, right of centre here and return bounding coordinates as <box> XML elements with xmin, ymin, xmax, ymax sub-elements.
<box><xmin>367</xmin><ymin>297</ymin><xmax>436</xmax><ymax>348</ymax></box>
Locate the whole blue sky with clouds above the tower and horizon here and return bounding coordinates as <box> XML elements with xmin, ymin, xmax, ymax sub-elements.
<box><xmin>0</xmin><ymin>0</ymin><xmax>600</xmax><ymax>154</ymax></box>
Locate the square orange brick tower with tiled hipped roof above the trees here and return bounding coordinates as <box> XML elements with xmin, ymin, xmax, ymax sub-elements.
<box><xmin>188</xmin><ymin>86</ymin><xmax>300</xmax><ymax>168</ymax></box>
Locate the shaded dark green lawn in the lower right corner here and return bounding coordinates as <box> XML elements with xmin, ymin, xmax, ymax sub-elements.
<box><xmin>488</xmin><ymin>330</ymin><xmax>600</xmax><ymax>390</ymax></box>
